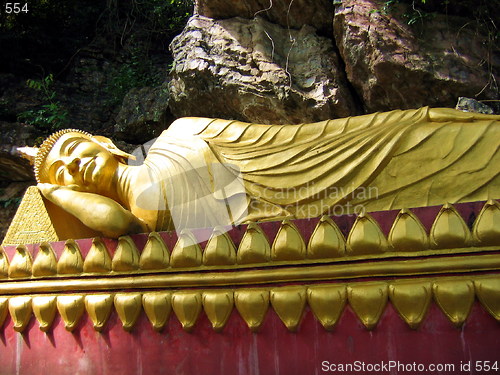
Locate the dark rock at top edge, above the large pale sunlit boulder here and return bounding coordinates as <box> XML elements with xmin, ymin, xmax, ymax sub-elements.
<box><xmin>194</xmin><ymin>0</ymin><xmax>333</xmax><ymax>31</ymax></box>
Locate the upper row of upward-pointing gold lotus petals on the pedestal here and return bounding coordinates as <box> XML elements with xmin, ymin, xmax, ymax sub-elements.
<box><xmin>0</xmin><ymin>200</ymin><xmax>500</xmax><ymax>281</ymax></box>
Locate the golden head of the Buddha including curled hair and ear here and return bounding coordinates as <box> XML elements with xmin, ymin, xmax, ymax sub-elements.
<box><xmin>34</xmin><ymin>129</ymin><xmax>132</xmax><ymax>193</ymax></box>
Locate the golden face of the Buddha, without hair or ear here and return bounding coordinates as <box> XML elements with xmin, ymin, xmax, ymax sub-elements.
<box><xmin>45</xmin><ymin>133</ymin><xmax>118</xmax><ymax>195</ymax></box>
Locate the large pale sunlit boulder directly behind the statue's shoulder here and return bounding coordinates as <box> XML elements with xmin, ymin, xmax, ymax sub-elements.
<box><xmin>170</xmin><ymin>16</ymin><xmax>355</xmax><ymax>123</ymax></box>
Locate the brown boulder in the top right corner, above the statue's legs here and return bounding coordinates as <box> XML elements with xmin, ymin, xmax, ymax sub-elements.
<box><xmin>334</xmin><ymin>0</ymin><xmax>500</xmax><ymax>112</ymax></box>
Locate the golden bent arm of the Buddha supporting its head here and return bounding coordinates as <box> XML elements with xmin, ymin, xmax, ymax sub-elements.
<box><xmin>38</xmin><ymin>184</ymin><xmax>147</xmax><ymax>238</ymax></box>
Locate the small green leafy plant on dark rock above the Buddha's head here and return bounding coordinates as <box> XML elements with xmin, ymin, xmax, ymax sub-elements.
<box><xmin>18</xmin><ymin>74</ymin><xmax>68</xmax><ymax>133</ymax></box>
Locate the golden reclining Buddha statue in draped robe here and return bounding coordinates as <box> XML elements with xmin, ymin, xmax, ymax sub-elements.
<box><xmin>25</xmin><ymin>107</ymin><xmax>500</xmax><ymax>237</ymax></box>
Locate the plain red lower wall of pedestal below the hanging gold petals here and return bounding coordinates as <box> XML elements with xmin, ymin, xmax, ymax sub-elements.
<box><xmin>0</xmin><ymin>303</ymin><xmax>500</xmax><ymax>375</ymax></box>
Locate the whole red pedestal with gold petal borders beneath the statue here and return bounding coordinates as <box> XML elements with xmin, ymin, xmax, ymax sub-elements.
<box><xmin>0</xmin><ymin>201</ymin><xmax>500</xmax><ymax>375</ymax></box>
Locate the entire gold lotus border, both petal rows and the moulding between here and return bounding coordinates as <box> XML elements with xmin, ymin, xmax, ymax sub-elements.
<box><xmin>0</xmin><ymin>201</ymin><xmax>500</xmax><ymax>332</ymax></box>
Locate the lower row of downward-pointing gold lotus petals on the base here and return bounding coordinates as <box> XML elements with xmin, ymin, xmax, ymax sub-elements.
<box><xmin>0</xmin><ymin>275</ymin><xmax>500</xmax><ymax>332</ymax></box>
